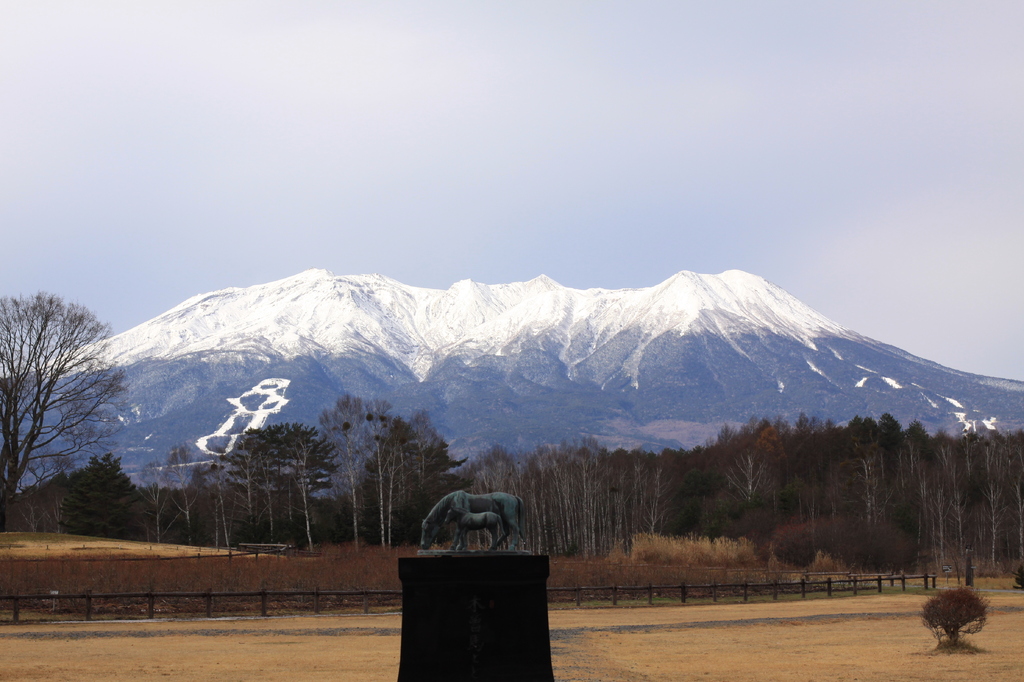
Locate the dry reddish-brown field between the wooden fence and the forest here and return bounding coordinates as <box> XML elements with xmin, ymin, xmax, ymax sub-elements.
<box><xmin>0</xmin><ymin>534</ymin><xmax>921</xmax><ymax>594</ymax></box>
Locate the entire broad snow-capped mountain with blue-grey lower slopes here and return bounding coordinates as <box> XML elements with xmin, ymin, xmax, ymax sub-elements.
<box><xmin>111</xmin><ymin>269</ymin><xmax>1024</xmax><ymax>466</ymax></box>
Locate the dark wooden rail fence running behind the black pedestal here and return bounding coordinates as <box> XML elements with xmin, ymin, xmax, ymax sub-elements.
<box><xmin>0</xmin><ymin>573</ymin><xmax>937</xmax><ymax>623</ymax></box>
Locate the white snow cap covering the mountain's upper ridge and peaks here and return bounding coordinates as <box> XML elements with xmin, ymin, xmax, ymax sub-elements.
<box><xmin>111</xmin><ymin>269</ymin><xmax>858</xmax><ymax>378</ymax></box>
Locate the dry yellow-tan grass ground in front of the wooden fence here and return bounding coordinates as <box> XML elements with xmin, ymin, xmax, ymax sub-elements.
<box><xmin>0</xmin><ymin>592</ymin><xmax>1024</xmax><ymax>682</ymax></box>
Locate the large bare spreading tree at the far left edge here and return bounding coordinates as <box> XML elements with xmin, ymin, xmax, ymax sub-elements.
<box><xmin>0</xmin><ymin>293</ymin><xmax>125</xmax><ymax>531</ymax></box>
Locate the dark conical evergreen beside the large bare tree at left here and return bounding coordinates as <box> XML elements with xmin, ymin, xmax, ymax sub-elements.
<box><xmin>60</xmin><ymin>453</ymin><xmax>135</xmax><ymax>538</ymax></box>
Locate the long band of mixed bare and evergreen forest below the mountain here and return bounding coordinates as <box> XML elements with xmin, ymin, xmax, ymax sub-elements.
<box><xmin>13</xmin><ymin>395</ymin><xmax>1024</xmax><ymax>570</ymax></box>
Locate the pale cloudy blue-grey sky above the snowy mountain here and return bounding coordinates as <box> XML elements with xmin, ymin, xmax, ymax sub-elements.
<box><xmin>0</xmin><ymin>0</ymin><xmax>1024</xmax><ymax>380</ymax></box>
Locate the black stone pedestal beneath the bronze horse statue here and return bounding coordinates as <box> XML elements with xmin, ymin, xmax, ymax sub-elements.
<box><xmin>398</xmin><ymin>553</ymin><xmax>554</xmax><ymax>682</ymax></box>
